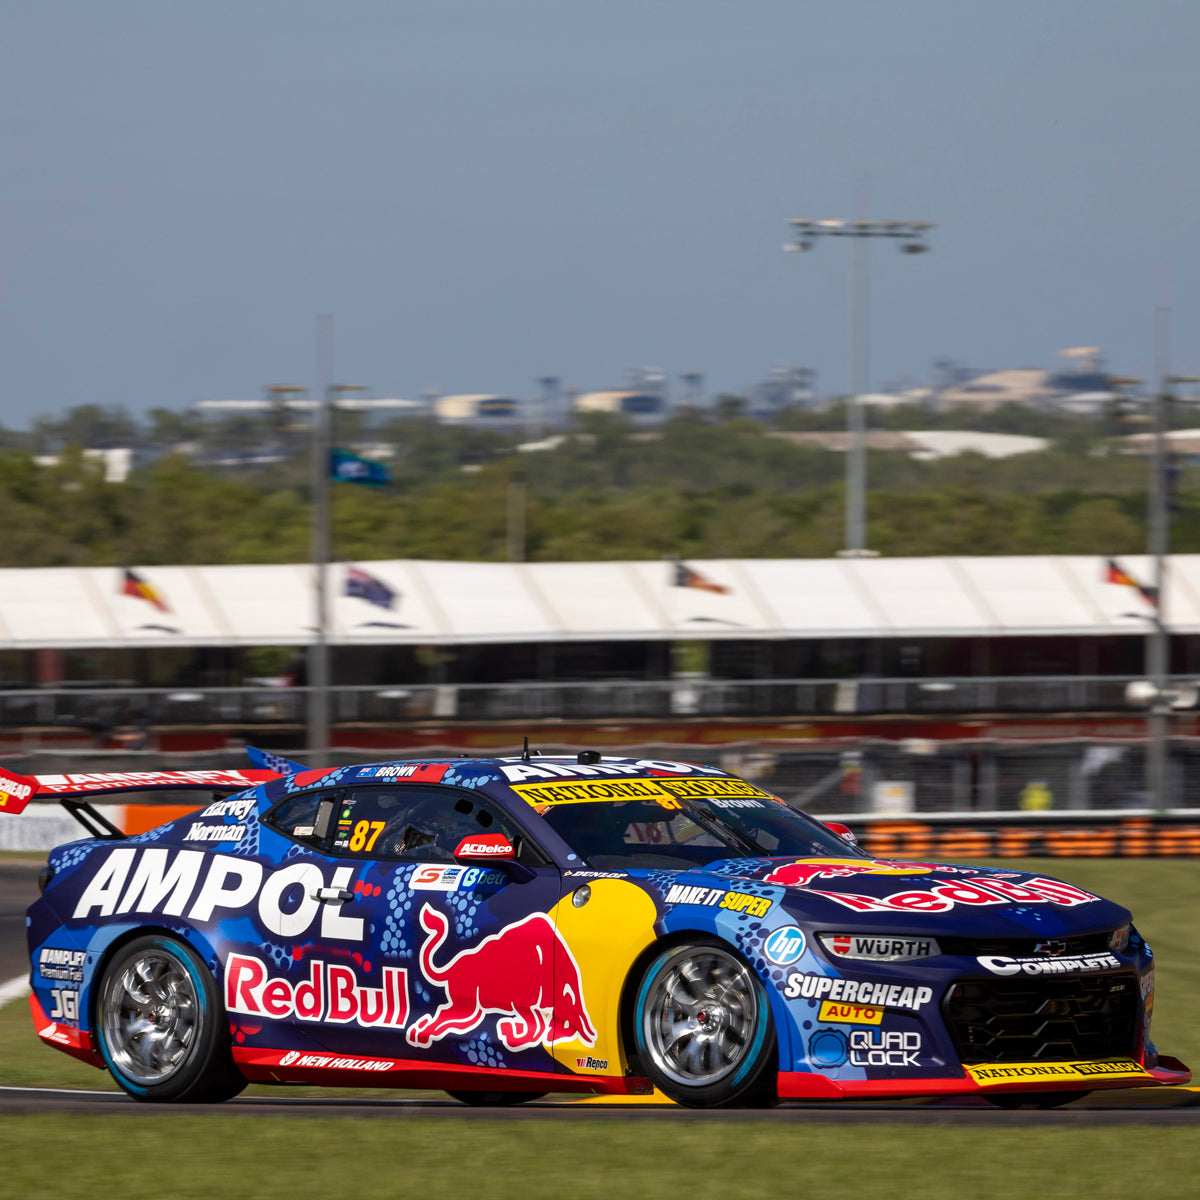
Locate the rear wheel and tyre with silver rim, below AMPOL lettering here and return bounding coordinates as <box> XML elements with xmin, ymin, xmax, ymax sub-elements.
<box><xmin>95</xmin><ymin>934</ymin><xmax>246</xmax><ymax>1104</ymax></box>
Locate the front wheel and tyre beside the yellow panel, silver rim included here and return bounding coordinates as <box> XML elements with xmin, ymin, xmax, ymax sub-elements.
<box><xmin>632</xmin><ymin>936</ymin><xmax>779</xmax><ymax>1109</ymax></box>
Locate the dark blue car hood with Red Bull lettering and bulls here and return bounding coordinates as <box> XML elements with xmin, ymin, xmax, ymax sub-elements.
<box><xmin>680</xmin><ymin>858</ymin><xmax>1129</xmax><ymax>937</ymax></box>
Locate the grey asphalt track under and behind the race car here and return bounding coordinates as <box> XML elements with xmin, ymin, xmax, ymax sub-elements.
<box><xmin>7</xmin><ymin>857</ymin><xmax>1200</xmax><ymax>1128</ymax></box>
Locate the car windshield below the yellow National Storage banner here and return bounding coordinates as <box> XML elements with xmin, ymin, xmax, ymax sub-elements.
<box><xmin>542</xmin><ymin>798</ymin><xmax>866</xmax><ymax>870</ymax></box>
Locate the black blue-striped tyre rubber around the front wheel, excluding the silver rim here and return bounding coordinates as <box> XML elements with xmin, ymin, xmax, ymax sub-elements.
<box><xmin>632</xmin><ymin>935</ymin><xmax>779</xmax><ymax>1109</ymax></box>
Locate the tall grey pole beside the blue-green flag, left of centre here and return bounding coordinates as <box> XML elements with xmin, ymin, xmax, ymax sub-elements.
<box><xmin>308</xmin><ymin>316</ymin><xmax>334</xmax><ymax>767</ymax></box>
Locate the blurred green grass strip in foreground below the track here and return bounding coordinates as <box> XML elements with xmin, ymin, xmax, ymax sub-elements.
<box><xmin>4</xmin><ymin>1115</ymin><xmax>1200</xmax><ymax>1200</ymax></box>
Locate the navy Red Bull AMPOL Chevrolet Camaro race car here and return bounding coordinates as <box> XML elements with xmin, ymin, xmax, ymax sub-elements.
<box><xmin>0</xmin><ymin>751</ymin><xmax>1190</xmax><ymax>1106</ymax></box>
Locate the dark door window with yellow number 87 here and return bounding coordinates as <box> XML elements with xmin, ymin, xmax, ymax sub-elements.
<box><xmin>332</xmin><ymin>784</ymin><xmax>530</xmax><ymax>863</ymax></box>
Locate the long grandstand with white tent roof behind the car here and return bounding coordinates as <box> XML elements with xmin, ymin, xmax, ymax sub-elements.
<box><xmin>0</xmin><ymin>554</ymin><xmax>1200</xmax><ymax>811</ymax></box>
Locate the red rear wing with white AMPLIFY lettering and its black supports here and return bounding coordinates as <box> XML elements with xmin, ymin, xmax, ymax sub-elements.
<box><xmin>0</xmin><ymin>767</ymin><xmax>280</xmax><ymax>839</ymax></box>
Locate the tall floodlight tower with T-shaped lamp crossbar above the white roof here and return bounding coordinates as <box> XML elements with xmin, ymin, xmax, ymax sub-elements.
<box><xmin>784</xmin><ymin>217</ymin><xmax>934</xmax><ymax>558</ymax></box>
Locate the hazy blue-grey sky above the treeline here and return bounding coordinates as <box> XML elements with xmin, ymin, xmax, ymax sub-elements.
<box><xmin>0</xmin><ymin>0</ymin><xmax>1200</xmax><ymax>427</ymax></box>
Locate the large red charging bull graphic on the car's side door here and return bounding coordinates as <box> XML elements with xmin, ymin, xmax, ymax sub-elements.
<box><xmin>408</xmin><ymin>904</ymin><xmax>596</xmax><ymax>1050</ymax></box>
